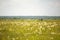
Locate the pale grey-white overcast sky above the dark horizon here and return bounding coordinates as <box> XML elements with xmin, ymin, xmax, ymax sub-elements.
<box><xmin>0</xmin><ymin>0</ymin><xmax>60</xmax><ymax>16</ymax></box>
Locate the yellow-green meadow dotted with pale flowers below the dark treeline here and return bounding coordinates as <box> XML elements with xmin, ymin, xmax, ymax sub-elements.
<box><xmin>0</xmin><ymin>19</ymin><xmax>60</xmax><ymax>40</ymax></box>
